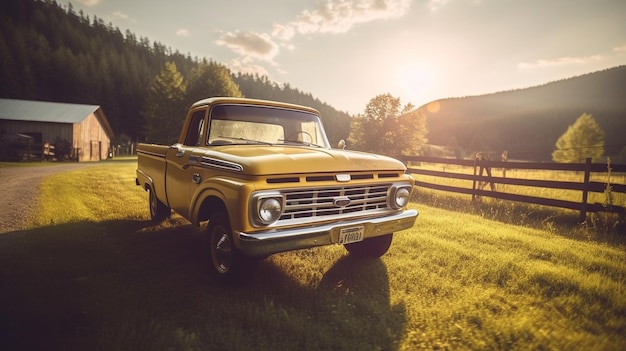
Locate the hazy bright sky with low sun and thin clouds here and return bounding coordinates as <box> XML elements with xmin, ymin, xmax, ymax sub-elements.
<box><xmin>67</xmin><ymin>0</ymin><xmax>626</xmax><ymax>115</ymax></box>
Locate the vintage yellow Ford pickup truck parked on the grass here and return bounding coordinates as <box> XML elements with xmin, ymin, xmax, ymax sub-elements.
<box><xmin>136</xmin><ymin>97</ymin><xmax>418</xmax><ymax>280</ymax></box>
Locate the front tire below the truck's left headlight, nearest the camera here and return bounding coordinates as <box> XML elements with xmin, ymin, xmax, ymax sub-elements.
<box><xmin>207</xmin><ymin>212</ymin><xmax>255</xmax><ymax>283</ymax></box>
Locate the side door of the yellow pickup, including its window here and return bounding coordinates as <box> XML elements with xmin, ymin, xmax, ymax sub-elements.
<box><xmin>165</xmin><ymin>109</ymin><xmax>206</xmax><ymax>219</ymax></box>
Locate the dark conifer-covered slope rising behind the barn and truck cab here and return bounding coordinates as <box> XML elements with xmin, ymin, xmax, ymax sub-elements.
<box><xmin>0</xmin><ymin>0</ymin><xmax>350</xmax><ymax>142</ymax></box>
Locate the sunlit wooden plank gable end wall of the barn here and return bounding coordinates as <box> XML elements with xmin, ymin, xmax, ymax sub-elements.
<box><xmin>73</xmin><ymin>113</ymin><xmax>111</xmax><ymax>161</ymax></box>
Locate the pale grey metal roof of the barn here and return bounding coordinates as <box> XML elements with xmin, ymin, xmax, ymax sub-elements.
<box><xmin>0</xmin><ymin>99</ymin><xmax>113</xmax><ymax>138</ymax></box>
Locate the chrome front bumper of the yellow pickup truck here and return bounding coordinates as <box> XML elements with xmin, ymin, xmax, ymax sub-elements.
<box><xmin>238</xmin><ymin>209</ymin><xmax>419</xmax><ymax>256</ymax></box>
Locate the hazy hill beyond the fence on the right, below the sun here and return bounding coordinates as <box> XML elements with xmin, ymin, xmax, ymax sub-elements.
<box><xmin>420</xmin><ymin>66</ymin><xmax>626</xmax><ymax>162</ymax></box>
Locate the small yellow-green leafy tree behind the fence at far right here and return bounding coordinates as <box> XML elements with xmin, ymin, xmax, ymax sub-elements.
<box><xmin>552</xmin><ymin>113</ymin><xmax>604</xmax><ymax>163</ymax></box>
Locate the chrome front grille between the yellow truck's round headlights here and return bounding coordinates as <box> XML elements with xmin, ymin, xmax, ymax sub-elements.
<box><xmin>279</xmin><ymin>184</ymin><xmax>391</xmax><ymax>221</ymax></box>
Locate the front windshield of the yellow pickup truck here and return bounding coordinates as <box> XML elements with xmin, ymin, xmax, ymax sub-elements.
<box><xmin>207</xmin><ymin>105</ymin><xmax>330</xmax><ymax>148</ymax></box>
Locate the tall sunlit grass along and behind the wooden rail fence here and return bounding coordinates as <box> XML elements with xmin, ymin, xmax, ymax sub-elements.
<box><xmin>404</xmin><ymin>163</ymin><xmax>626</xmax><ymax>239</ymax></box>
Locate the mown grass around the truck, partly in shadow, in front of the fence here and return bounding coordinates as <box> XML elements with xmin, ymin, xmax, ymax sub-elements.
<box><xmin>0</xmin><ymin>160</ymin><xmax>626</xmax><ymax>350</ymax></box>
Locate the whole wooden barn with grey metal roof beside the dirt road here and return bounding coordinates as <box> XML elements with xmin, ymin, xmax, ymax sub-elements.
<box><xmin>0</xmin><ymin>99</ymin><xmax>113</xmax><ymax>162</ymax></box>
